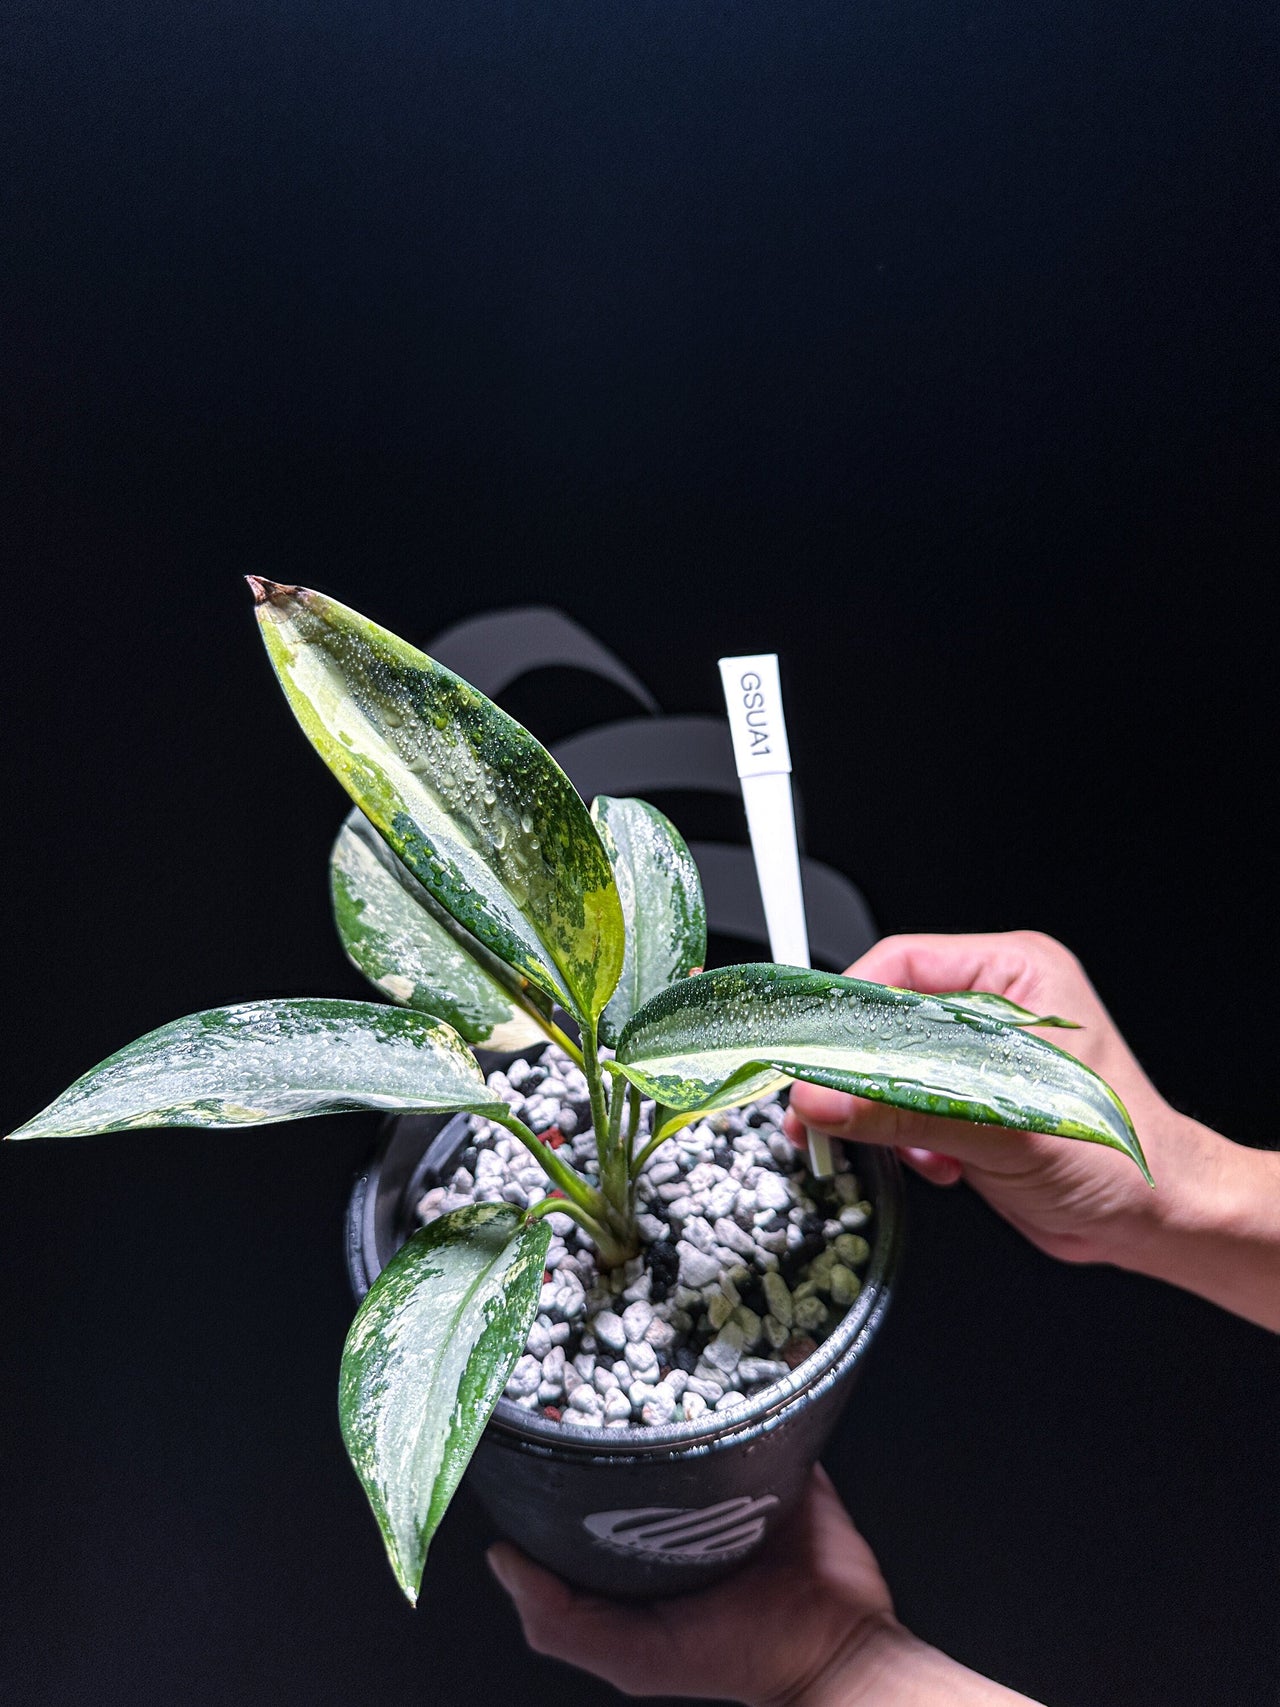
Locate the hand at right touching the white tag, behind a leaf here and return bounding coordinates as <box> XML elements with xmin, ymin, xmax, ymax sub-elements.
<box><xmin>788</xmin><ymin>930</ymin><xmax>1280</xmax><ymax>1328</ymax></box>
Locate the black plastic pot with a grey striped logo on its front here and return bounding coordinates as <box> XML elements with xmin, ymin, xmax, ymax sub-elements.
<box><xmin>346</xmin><ymin>1115</ymin><xmax>903</xmax><ymax>1599</ymax></box>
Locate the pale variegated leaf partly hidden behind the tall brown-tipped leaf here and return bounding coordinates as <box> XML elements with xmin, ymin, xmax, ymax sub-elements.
<box><xmin>329</xmin><ymin>807</ymin><xmax>551</xmax><ymax>1052</ymax></box>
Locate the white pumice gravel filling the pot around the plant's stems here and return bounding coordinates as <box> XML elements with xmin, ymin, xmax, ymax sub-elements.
<box><xmin>418</xmin><ymin>1045</ymin><xmax>872</xmax><ymax>1429</ymax></box>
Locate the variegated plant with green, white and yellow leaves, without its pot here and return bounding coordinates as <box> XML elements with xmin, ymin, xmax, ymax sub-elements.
<box><xmin>14</xmin><ymin>577</ymin><xmax>1147</xmax><ymax>1599</ymax></box>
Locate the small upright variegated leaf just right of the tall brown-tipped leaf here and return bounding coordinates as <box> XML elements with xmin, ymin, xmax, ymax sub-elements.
<box><xmin>591</xmin><ymin>794</ymin><xmax>707</xmax><ymax>1045</ymax></box>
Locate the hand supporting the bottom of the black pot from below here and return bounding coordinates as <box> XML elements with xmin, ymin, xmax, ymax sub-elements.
<box><xmin>488</xmin><ymin>1466</ymin><xmax>1024</xmax><ymax>1707</ymax></box>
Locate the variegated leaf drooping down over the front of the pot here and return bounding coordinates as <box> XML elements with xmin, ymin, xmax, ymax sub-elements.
<box><xmin>338</xmin><ymin>1203</ymin><xmax>551</xmax><ymax>1603</ymax></box>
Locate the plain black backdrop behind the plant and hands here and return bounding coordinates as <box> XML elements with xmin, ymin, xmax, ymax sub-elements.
<box><xmin>0</xmin><ymin>0</ymin><xmax>1280</xmax><ymax>1707</ymax></box>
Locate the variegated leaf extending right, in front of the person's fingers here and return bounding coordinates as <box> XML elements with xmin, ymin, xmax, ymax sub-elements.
<box><xmin>618</xmin><ymin>964</ymin><xmax>1150</xmax><ymax>1180</ymax></box>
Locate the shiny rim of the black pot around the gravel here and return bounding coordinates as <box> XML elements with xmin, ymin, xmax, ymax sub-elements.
<box><xmin>346</xmin><ymin>1113</ymin><xmax>905</xmax><ymax>1463</ymax></box>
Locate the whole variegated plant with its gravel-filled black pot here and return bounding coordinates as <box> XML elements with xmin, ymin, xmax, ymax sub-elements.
<box><xmin>12</xmin><ymin>577</ymin><xmax>1150</xmax><ymax>1599</ymax></box>
